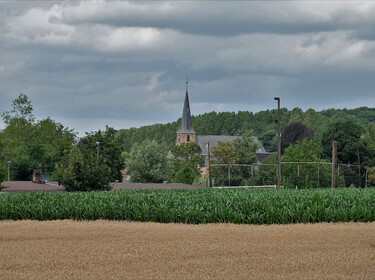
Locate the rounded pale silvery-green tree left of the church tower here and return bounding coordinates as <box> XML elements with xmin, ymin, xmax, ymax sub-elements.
<box><xmin>126</xmin><ymin>140</ymin><xmax>170</xmax><ymax>183</ymax></box>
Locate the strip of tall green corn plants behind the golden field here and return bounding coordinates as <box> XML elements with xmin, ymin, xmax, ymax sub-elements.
<box><xmin>0</xmin><ymin>189</ymin><xmax>375</xmax><ymax>224</ymax></box>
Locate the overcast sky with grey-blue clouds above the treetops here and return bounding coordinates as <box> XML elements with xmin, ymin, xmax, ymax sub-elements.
<box><xmin>0</xmin><ymin>0</ymin><xmax>375</xmax><ymax>135</ymax></box>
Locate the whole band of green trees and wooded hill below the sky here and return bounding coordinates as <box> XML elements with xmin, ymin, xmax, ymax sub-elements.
<box><xmin>0</xmin><ymin>94</ymin><xmax>375</xmax><ymax>190</ymax></box>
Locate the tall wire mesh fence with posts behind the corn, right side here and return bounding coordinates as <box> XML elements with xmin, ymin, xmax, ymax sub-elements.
<box><xmin>211</xmin><ymin>162</ymin><xmax>366</xmax><ymax>188</ymax></box>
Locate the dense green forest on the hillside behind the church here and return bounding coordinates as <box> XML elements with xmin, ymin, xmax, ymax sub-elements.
<box><xmin>119</xmin><ymin>107</ymin><xmax>375</xmax><ymax>152</ymax></box>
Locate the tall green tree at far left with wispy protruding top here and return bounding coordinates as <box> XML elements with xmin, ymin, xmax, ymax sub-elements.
<box><xmin>0</xmin><ymin>94</ymin><xmax>75</xmax><ymax>180</ymax></box>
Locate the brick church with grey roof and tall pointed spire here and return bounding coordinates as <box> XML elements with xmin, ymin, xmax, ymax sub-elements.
<box><xmin>176</xmin><ymin>81</ymin><xmax>270</xmax><ymax>165</ymax></box>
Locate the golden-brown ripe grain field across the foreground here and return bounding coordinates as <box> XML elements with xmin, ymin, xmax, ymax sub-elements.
<box><xmin>0</xmin><ymin>221</ymin><xmax>375</xmax><ymax>279</ymax></box>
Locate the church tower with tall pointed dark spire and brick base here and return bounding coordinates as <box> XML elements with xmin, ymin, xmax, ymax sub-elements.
<box><xmin>176</xmin><ymin>79</ymin><xmax>197</xmax><ymax>145</ymax></box>
